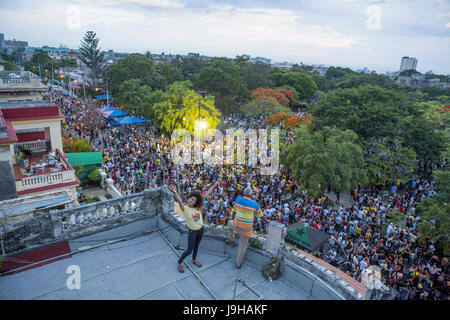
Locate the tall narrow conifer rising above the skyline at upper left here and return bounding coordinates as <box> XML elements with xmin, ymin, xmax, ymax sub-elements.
<box><xmin>80</xmin><ymin>31</ymin><xmax>104</xmax><ymax>87</ymax></box>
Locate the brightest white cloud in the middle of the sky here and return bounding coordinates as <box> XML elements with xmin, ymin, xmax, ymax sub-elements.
<box><xmin>181</xmin><ymin>5</ymin><xmax>356</xmax><ymax>47</ymax></box>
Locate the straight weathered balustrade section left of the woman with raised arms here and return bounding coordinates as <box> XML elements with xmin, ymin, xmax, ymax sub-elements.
<box><xmin>2</xmin><ymin>188</ymin><xmax>162</xmax><ymax>254</ymax></box>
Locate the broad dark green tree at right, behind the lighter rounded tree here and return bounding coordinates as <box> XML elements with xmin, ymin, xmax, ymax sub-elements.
<box><xmin>312</xmin><ymin>85</ymin><xmax>444</xmax><ymax>158</ymax></box>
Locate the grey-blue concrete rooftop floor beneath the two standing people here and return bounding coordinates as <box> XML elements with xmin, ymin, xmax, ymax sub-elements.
<box><xmin>0</xmin><ymin>232</ymin><xmax>307</xmax><ymax>300</ymax></box>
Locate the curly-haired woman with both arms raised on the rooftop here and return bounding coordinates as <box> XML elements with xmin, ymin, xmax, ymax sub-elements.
<box><xmin>170</xmin><ymin>181</ymin><xmax>218</xmax><ymax>272</ymax></box>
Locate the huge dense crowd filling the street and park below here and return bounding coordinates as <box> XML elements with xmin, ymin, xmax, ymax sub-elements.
<box><xmin>49</xmin><ymin>90</ymin><xmax>450</xmax><ymax>300</ymax></box>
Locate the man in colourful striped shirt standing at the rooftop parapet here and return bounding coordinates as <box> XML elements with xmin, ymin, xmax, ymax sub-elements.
<box><xmin>228</xmin><ymin>187</ymin><xmax>269</xmax><ymax>269</ymax></box>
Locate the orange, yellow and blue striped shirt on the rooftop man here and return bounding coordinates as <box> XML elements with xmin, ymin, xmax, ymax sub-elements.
<box><xmin>231</xmin><ymin>197</ymin><xmax>263</xmax><ymax>237</ymax></box>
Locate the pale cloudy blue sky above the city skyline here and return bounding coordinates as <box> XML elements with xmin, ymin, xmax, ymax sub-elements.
<box><xmin>0</xmin><ymin>0</ymin><xmax>450</xmax><ymax>74</ymax></box>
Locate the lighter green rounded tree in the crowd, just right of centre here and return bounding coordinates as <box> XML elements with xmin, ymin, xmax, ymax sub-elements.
<box><xmin>282</xmin><ymin>126</ymin><xmax>367</xmax><ymax>197</ymax></box>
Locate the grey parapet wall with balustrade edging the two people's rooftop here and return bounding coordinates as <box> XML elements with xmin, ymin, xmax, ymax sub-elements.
<box><xmin>4</xmin><ymin>187</ymin><xmax>376</xmax><ymax>300</ymax></box>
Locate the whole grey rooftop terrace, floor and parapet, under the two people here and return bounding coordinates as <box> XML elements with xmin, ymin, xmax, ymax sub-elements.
<box><xmin>0</xmin><ymin>187</ymin><xmax>394</xmax><ymax>300</ymax></box>
